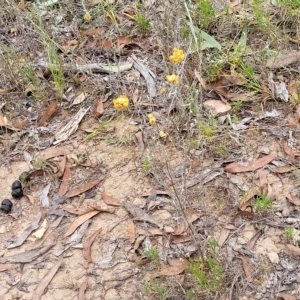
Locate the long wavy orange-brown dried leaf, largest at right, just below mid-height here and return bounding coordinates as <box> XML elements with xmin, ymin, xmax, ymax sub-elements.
<box><xmin>225</xmin><ymin>153</ymin><xmax>277</xmax><ymax>173</ymax></box>
